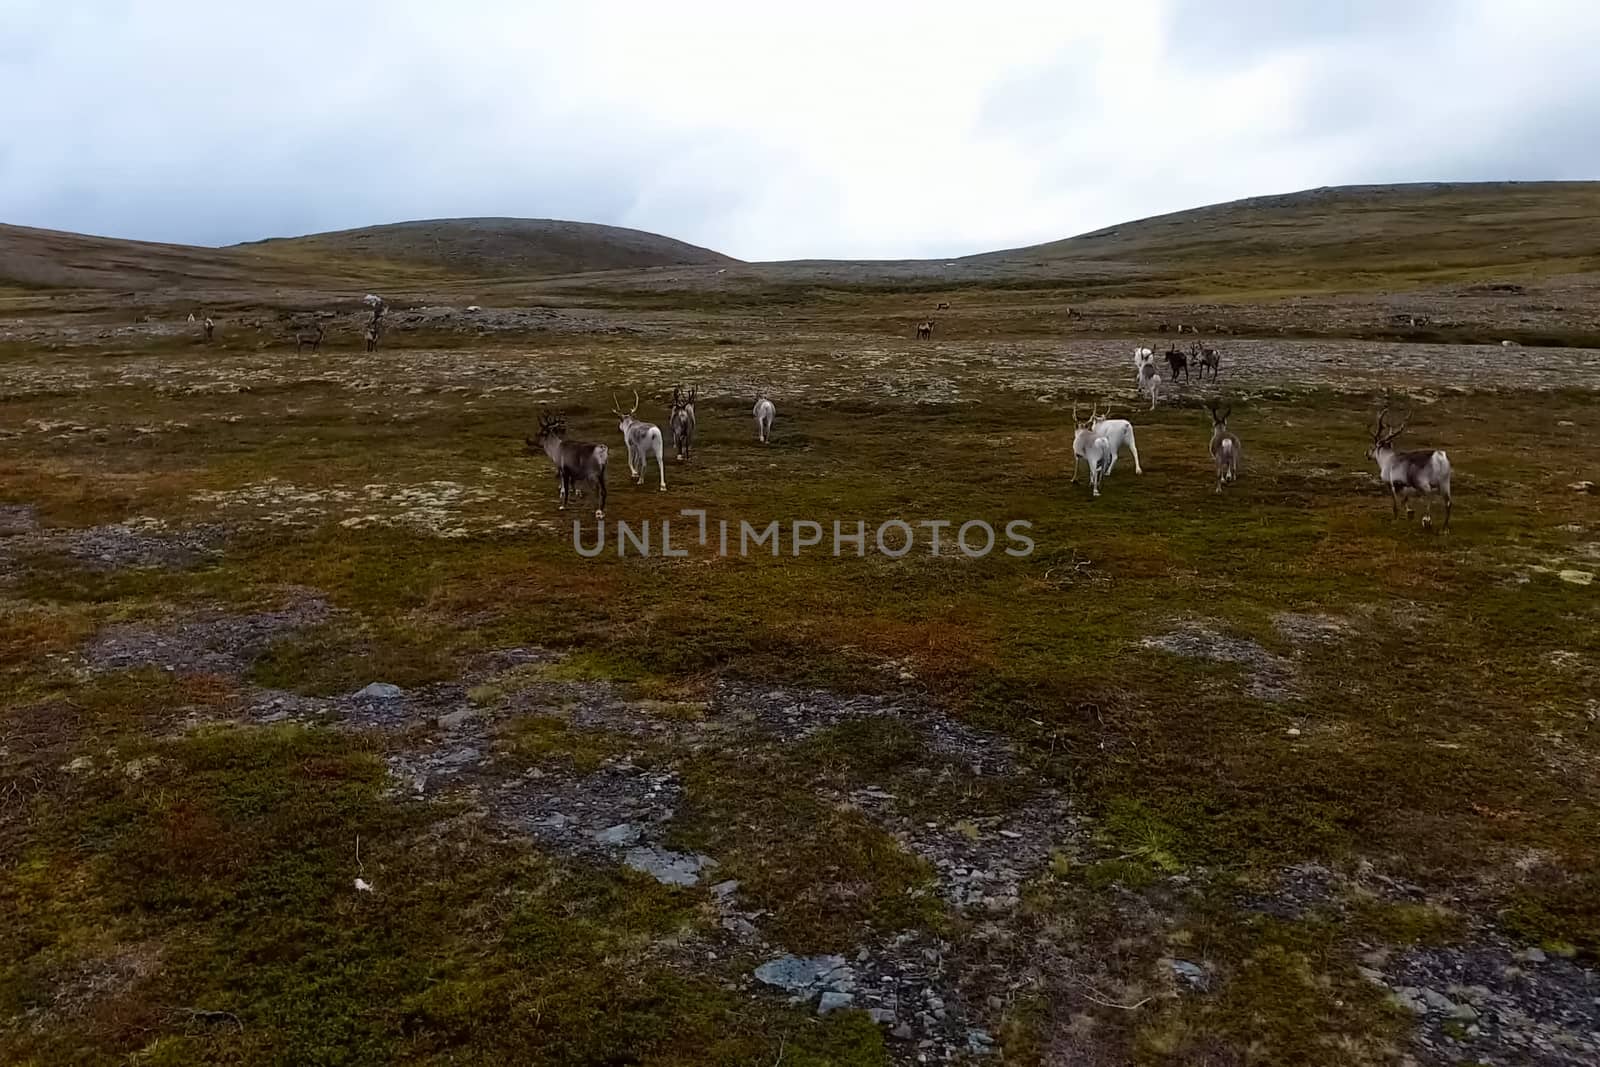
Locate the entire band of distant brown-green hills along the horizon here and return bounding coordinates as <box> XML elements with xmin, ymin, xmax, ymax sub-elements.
<box><xmin>0</xmin><ymin>181</ymin><xmax>1600</xmax><ymax>291</ymax></box>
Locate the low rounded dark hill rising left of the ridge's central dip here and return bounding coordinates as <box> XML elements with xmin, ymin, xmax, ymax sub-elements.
<box><xmin>235</xmin><ymin>219</ymin><xmax>738</xmax><ymax>277</ymax></box>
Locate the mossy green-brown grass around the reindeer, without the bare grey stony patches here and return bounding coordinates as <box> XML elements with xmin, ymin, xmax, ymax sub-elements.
<box><xmin>0</xmin><ymin>309</ymin><xmax>1600</xmax><ymax>1064</ymax></box>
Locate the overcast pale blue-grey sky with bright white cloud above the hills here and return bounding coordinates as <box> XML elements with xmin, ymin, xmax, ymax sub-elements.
<box><xmin>0</xmin><ymin>0</ymin><xmax>1600</xmax><ymax>259</ymax></box>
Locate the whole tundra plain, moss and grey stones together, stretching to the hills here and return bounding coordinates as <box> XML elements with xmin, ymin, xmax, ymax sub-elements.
<box><xmin>0</xmin><ymin>186</ymin><xmax>1600</xmax><ymax>1065</ymax></box>
